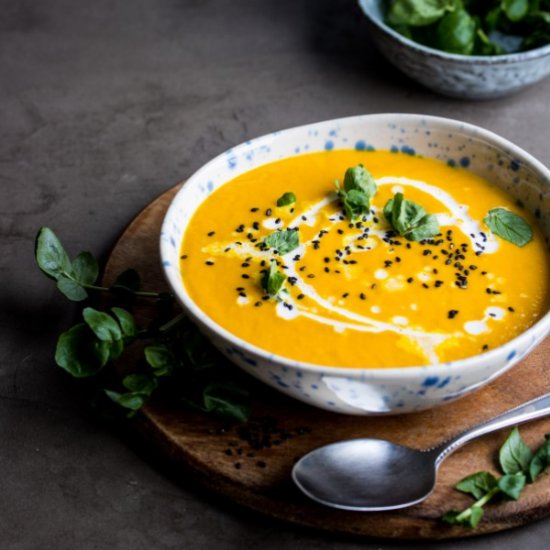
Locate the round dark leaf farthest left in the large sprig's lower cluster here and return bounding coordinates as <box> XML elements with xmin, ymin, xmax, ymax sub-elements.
<box><xmin>55</xmin><ymin>323</ymin><xmax>109</xmax><ymax>378</ymax></box>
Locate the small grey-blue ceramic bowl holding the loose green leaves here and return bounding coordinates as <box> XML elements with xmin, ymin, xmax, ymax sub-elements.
<box><xmin>359</xmin><ymin>0</ymin><xmax>550</xmax><ymax>99</ymax></box>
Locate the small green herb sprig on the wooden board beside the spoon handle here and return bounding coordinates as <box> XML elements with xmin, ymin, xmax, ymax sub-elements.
<box><xmin>442</xmin><ymin>427</ymin><xmax>550</xmax><ymax>527</ymax></box>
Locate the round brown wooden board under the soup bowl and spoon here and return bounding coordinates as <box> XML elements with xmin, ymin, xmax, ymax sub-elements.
<box><xmin>104</xmin><ymin>188</ymin><xmax>550</xmax><ymax>539</ymax></box>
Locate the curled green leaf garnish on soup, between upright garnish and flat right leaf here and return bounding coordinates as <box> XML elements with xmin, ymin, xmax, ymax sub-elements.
<box><xmin>384</xmin><ymin>193</ymin><xmax>439</xmax><ymax>241</ymax></box>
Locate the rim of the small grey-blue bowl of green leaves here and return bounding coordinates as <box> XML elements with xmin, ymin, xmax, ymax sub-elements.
<box><xmin>357</xmin><ymin>0</ymin><xmax>550</xmax><ymax>65</ymax></box>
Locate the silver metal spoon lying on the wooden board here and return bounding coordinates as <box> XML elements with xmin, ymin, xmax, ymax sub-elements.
<box><xmin>292</xmin><ymin>393</ymin><xmax>550</xmax><ymax>512</ymax></box>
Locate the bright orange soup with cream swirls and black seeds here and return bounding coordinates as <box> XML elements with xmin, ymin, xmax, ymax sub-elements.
<box><xmin>181</xmin><ymin>150</ymin><xmax>550</xmax><ymax>367</ymax></box>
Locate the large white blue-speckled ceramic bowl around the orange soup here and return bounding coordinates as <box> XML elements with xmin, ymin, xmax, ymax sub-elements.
<box><xmin>160</xmin><ymin>114</ymin><xmax>550</xmax><ymax>415</ymax></box>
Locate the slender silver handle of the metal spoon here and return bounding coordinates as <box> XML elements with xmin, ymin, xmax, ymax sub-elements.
<box><xmin>431</xmin><ymin>393</ymin><xmax>550</xmax><ymax>468</ymax></box>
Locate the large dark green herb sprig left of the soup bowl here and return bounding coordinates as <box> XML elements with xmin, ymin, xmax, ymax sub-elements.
<box><xmin>35</xmin><ymin>227</ymin><xmax>250</xmax><ymax>421</ymax></box>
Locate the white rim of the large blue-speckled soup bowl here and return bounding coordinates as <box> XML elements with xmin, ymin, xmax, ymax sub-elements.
<box><xmin>159</xmin><ymin>113</ymin><xmax>550</xmax><ymax>380</ymax></box>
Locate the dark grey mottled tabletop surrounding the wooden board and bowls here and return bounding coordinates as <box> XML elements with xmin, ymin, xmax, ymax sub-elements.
<box><xmin>0</xmin><ymin>0</ymin><xmax>550</xmax><ymax>550</ymax></box>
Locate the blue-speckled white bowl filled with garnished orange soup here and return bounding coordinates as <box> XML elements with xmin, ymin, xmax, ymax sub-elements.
<box><xmin>160</xmin><ymin>114</ymin><xmax>550</xmax><ymax>415</ymax></box>
